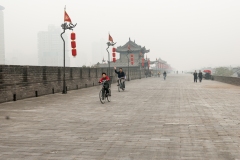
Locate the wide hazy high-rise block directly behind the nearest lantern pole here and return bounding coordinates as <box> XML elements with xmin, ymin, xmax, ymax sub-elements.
<box><xmin>38</xmin><ymin>26</ymin><xmax>70</xmax><ymax>66</ymax></box>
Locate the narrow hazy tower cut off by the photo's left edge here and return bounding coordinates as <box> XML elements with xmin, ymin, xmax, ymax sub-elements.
<box><xmin>0</xmin><ymin>6</ymin><xmax>5</xmax><ymax>64</ymax></box>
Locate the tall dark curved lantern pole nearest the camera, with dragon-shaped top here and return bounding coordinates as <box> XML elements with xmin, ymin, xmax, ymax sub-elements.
<box><xmin>61</xmin><ymin>6</ymin><xmax>77</xmax><ymax>94</ymax></box>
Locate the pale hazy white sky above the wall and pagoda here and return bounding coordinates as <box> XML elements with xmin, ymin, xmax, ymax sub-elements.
<box><xmin>0</xmin><ymin>0</ymin><xmax>240</xmax><ymax>70</ymax></box>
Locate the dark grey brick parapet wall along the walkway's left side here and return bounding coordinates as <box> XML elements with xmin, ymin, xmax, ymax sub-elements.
<box><xmin>0</xmin><ymin>65</ymin><xmax>145</xmax><ymax>103</ymax></box>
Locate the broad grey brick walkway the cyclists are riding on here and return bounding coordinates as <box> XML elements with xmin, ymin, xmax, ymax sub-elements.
<box><xmin>0</xmin><ymin>74</ymin><xmax>240</xmax><ymax>160</ymax></box>
